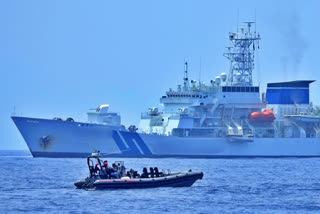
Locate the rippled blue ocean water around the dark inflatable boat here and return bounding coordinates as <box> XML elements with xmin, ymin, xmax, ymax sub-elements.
<box><xmin>0</xmin><ymin>151</ymin><xmax>320</xmax><ymax>214</ymax></box>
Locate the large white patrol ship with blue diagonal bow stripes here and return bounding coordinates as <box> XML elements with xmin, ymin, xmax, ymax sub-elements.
<box><xmin>12</xmin><ymin>22</ymin><xmax>320</xmax><ymax>158</ymax></box>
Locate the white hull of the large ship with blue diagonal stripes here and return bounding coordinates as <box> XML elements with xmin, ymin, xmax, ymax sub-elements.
<box><xmin>12</xmin><ymin>117</ymin><xmax>320</xmax><ymax>158</ymax></box>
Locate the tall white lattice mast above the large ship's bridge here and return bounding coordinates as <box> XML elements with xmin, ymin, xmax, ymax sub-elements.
<box><xmin>223</xmin><ymin>22</ymin><xmax>261</xmax><ymax>86</ymax></box>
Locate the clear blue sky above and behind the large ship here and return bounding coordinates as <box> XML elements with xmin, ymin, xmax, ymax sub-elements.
<box><xmin>0</xmin><ymin>0</ymin><xmax>320</xmax><ymax>149</ymax></box>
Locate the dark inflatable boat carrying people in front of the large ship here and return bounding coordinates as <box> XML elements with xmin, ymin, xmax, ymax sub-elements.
<box><xmin>74</xmin><ymin>154</ymin><xmax>203</xmax><ymax>189</ymax></box>
